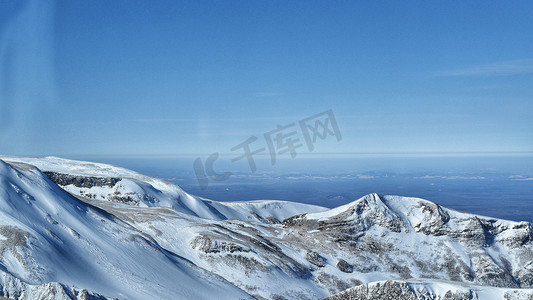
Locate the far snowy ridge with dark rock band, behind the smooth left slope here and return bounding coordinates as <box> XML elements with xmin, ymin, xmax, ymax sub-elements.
<box><xmin>0</xmin><ymin>156</ymin><xmax>326</xmax><ymax>222</ymax></box>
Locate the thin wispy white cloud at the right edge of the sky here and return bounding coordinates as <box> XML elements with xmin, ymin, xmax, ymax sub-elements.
<box><xmin>437</xmin><ymin>59</ymin><xmax>533</xmax><ymax>77</ymax></box>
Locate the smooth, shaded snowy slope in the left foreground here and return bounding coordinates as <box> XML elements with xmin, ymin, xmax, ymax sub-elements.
<box><xmin>0</xmin><ymin>160</ymin><xmax>247</xmax><ymax>299</ymax></box>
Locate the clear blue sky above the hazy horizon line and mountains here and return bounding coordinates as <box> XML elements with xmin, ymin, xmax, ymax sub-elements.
<box><xmin>0</xmin><ymin>0</ymin><xmax>533</xmax><ymax>156</ymax></box>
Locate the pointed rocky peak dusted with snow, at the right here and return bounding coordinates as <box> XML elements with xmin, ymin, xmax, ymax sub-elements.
<box><xmin>282</xmin><ymin>194</ymin><xmax>533</xmax><ymax>288</ymax></box>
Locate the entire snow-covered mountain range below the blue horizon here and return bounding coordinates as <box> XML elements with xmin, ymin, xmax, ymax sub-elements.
<box><xmin>0</xmin><ymin>156</ymin><xmax>533</xmax><ymax>299</ymax></box>
